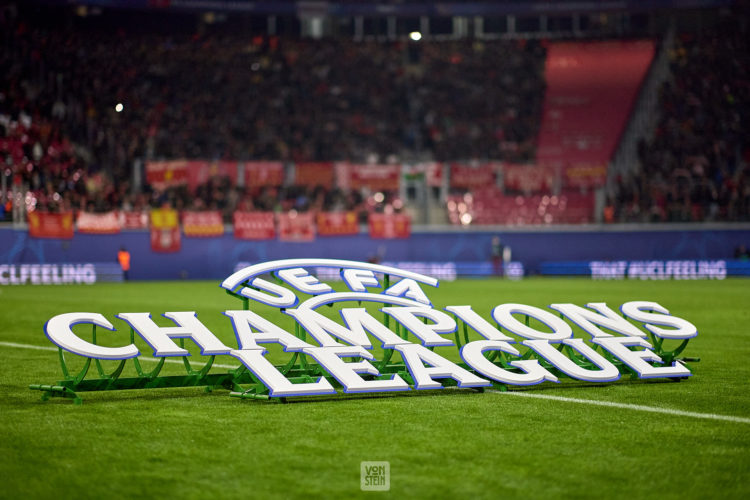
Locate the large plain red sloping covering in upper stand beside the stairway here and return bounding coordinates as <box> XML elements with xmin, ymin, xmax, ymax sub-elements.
<box><xmin>537</xmin><ymin>41</ymin><xmax>654</xmax><ymax>187</ymax></box>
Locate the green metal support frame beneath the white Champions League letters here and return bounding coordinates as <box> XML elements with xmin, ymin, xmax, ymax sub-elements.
<box><xmin>29</xmin><ymin>275</ymin><xmax>700</xmax><ymax>404</ymax></box>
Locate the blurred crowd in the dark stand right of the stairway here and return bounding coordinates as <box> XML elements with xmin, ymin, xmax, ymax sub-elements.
<box><xmin>609</xmin><ymin>22</ymin><xmax>750</xmax><ymax>222</ymax></box>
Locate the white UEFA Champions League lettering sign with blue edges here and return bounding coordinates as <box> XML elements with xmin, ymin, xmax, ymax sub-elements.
<box><xmin>39</xmin><ymin>259</ymin><xmax>698</xmax><ymax>397</ymax></box>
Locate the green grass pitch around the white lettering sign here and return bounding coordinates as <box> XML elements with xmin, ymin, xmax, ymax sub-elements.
<box><xmin>0</xmin><ymin>278</ymin><xmax>750</xmax><ymax>499</ymax></box>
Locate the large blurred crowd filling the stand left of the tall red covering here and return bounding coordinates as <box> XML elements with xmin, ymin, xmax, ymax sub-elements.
<box><xmin>0</xmin><ymin>2</ymin><xmax>544</xmax><ymax>219</ymax></box>
